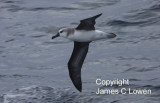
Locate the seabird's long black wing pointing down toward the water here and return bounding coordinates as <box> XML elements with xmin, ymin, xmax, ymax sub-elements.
<box><xmin>68</xmin><ymin>42</ymin><xmax>90</xmax><ymax>92</ymax></box>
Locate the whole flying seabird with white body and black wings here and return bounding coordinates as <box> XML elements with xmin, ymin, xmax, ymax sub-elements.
<box><xmin>52</xmin><ymin>13</ymin><xmax>116</xmax><ymax>92</ymax></box>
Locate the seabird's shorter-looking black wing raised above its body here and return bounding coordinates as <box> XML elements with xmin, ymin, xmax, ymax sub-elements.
<box><xmin>76</xmin><ymin>13</ymin><xmax>102</xmax><ymax>30</ymax></box>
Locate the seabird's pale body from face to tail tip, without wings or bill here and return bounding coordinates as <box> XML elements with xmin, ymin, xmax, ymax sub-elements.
<box><xmin>53</xmin><ymin>28</ymin><xmax>116</xmax><ymax>42</ymax></box>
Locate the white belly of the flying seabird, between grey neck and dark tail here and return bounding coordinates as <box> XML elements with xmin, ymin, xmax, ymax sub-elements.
<box><xmin>68</xmin><ymin>30</ymin><xmax>107</xmax><ymax>42</ymax></box>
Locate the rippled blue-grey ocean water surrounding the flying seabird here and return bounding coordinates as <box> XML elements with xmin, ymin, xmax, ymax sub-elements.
<box><xmin>0</xmin><ymin>0</ymin><xmax>160</xmax><ymax>103</ymax></box>
